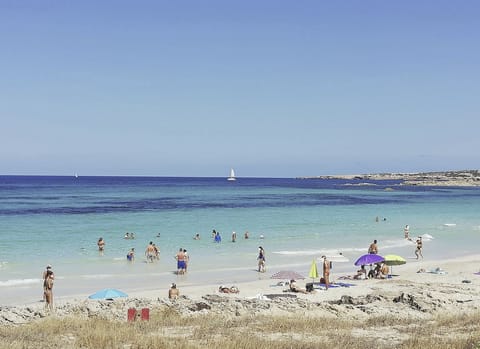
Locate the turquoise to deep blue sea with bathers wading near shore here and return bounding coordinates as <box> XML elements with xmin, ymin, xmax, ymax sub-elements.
<box><xmin>0</xmin><ymin>176</ymin><xmax>480</xmax><ymax>305</ymax></box>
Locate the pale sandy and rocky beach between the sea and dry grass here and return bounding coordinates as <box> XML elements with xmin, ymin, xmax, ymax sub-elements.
<box><xmin>0</xmin><ymin>251</ymin><xmax>480</xmax><ymax>325</ymax></box>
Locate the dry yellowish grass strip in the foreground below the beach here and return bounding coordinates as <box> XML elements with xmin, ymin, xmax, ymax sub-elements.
<box><xmin>0</xmin><ymin>310</ymin><xmax>480</xmax><ymax>349</ymax></box>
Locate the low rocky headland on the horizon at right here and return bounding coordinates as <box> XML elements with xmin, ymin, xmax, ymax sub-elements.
<box><xmin>297</xmin><ymin>170</ymin><xmax>480</xmax><ymax>187</ymax></box>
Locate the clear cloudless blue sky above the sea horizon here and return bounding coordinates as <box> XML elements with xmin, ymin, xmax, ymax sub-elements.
<box><xmin>0</xmin><ymin>0</ymin><xmax>480</xmax><ymax>177</ymax></box>
